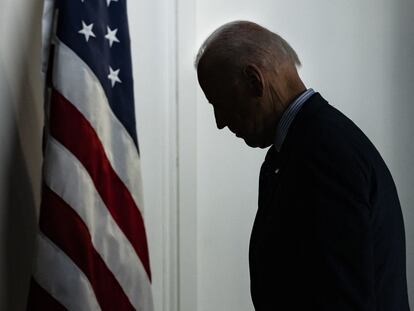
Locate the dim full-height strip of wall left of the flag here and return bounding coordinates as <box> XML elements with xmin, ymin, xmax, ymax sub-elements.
<box><xmin>0</xmin><ymin>1</ymin><xmax>43</xmax><ymax>310</ymax></box>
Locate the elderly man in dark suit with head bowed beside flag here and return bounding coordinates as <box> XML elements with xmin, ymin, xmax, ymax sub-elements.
<box><xmin>196</xmin><ymin>21</ymin><xmax>409</xmax><ymax>311</ymax></box>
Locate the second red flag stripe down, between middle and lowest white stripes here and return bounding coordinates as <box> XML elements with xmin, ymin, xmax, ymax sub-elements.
<box><xmin>39</xmin><ymin>186</ymin><xmax>135</xmax><ymax>310</ymax></box>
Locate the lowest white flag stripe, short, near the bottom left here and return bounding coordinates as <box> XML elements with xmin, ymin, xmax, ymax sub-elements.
<box><xmin>33</xmin><ymin>232</ymin><xmax>101</xmax><ymax>311</ymax></box>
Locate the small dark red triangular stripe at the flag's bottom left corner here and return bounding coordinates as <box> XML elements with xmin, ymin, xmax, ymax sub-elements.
<box><xmin>27</xmin><ymin>278</ymin><xmax>66</xmax><ymax>311</ymax></box>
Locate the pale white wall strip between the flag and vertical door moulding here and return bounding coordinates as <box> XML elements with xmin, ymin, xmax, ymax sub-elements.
<box><xmin>128</xmin><ymin>0</ymin><xmax>177</xmax><ymax>311</ymax></box>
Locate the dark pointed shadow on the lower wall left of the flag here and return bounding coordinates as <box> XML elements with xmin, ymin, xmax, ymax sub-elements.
<box><xmin>2</xmin><ymin>110</ymin><xmax>37</xmax><ymax>310</ymax></box>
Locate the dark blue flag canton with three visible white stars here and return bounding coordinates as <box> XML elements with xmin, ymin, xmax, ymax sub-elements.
<box><xmin>57</xmin><ymin>0</ymin><xmax>138</xmax><ymax>149</ymax></box>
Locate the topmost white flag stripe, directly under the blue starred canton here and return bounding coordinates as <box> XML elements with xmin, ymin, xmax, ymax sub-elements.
<box><xmin>53</xmin><ymin>37</ymin><xmax>143</xmax><ymax>214</ymax></box>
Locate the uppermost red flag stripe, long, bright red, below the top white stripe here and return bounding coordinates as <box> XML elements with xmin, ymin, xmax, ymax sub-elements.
<box><xmin>50</xmin><ymin>90</ymin><xmax>151</xmax><ymax>280</ymax></box>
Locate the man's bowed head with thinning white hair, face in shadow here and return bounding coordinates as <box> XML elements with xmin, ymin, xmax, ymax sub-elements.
<box><xmin>195</xmin><ymin>21</ymin><xmax>306</xmax><ymax>148</ymax></box>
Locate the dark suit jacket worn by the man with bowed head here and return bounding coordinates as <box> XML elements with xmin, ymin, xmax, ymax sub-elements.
<box><xmin>250</xmin><ymin>93</ymin><xmax>409</xmax><ymax>311</ymax></box>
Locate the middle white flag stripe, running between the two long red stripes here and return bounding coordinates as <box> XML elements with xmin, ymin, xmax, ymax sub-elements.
<box><xmin>44</xmin><ymin>137</ymin><xmax>153</xmax><ymax>311</ymax></box>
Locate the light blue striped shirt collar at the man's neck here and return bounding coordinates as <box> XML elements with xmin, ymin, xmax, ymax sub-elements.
<box><xmin>275</xmin><ymin>89</ymin><xmax>315</xmax><ymax>152</ymax></box>
